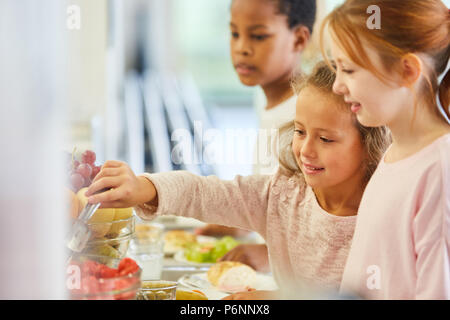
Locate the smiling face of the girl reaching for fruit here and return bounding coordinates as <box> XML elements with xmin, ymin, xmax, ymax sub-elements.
<box><xmin>292</xmin><ymin>86</ymin><xmax>366</xmax><ymax>188</ymax></box>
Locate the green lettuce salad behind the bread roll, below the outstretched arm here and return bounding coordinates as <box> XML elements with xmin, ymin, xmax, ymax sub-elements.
<box><xmin>184</xmin><ymin>236</ymin><xmax>239</xmax><ymax>263</ymax></box>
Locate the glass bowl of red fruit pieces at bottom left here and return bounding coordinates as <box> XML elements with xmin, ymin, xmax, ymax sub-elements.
<box><xmin>66</xmin><ymin>254</ymin><xmax>142</xmax><ymax>300</ymax></box>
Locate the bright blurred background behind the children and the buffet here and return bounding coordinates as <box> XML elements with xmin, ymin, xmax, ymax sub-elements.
<box><xmin>0</xmin><ymin>0</ymin><xmax>449</xmax><ymax>299</ymax></box>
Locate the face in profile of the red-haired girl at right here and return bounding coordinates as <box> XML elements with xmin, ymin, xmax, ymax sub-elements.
<box><xmin>331</xmin><ymin>41</ymin><xmax>411</xmax><ymax>127</ymax></box>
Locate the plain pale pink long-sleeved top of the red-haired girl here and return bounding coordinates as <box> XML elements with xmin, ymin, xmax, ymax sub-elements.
<box><xmin>341</xmin><ymin>134</ymin><xmax>450</xmax><ymax>299</ymax></box>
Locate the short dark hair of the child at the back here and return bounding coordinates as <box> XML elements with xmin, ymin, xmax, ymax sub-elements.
<box><xmin>270</xmin><ymin>0</ymin><xmax>317</xmax><ymax>33</ymax></box>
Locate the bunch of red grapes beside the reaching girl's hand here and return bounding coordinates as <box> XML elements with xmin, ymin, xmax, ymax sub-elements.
<box><xmin>69</xmin><ymin>150</ymin><xmax>101</xmax><ymax>193</ymax></box>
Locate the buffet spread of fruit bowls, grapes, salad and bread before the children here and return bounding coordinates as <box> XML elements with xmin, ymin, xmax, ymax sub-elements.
<box><xmin>63</xmin><ymin>150</ymin><xmax>266</xmax><ymax>300</ymax></box>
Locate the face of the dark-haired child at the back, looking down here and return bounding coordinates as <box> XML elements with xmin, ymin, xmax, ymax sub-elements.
<box><xmin>230</xmin><ymin>0</ymin><xmax>306</xmax><ymax>86</ymax></box>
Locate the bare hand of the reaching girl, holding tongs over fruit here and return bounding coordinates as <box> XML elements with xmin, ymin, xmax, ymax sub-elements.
<box><xmin>86</xmin><ymin>161</ymin><xmax>157</xmax><ymax>208</ymax></box>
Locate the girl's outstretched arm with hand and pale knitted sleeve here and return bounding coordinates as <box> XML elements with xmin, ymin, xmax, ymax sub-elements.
<box><xmin>86</xmin><ymin>161</ymin><xmax>272</xmax><ymax>236</ymax></box>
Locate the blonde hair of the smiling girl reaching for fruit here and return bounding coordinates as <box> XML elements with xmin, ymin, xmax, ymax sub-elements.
<box><xmin>279</xmin><ymin>61</ymin><xmax>391</xmax><ymax>182</ymax></box>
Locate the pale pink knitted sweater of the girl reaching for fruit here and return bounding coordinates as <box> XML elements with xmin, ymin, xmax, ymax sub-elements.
<box><xmin>135</xmin><ymin>169</ymin><xmax>356</xmax><ymax>291</ymax></box>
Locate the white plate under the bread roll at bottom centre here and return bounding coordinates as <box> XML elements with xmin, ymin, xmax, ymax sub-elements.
<box><xmin>178</xmin><ymin>272</ymin><xmax>278</xmax><ymax>300</ymax></box>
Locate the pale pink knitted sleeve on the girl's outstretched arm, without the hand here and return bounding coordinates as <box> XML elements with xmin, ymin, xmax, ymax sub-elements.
<box><xmin>136</xmin><ymin>171</ymin><xmax>272</xmax><ymax>236</ymax></box>
